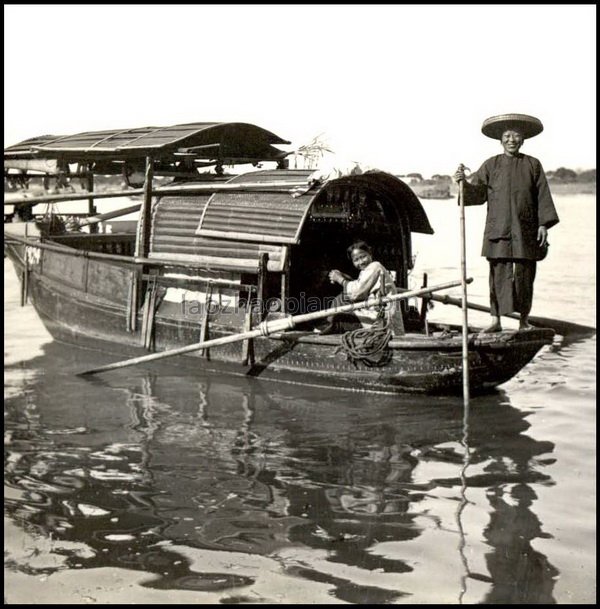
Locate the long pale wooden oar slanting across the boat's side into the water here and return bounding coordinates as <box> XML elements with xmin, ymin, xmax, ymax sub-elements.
<box><xmin>78</xmin><ymin>278</ymin><xmax>473</xmax><ymax>376</ymax></box>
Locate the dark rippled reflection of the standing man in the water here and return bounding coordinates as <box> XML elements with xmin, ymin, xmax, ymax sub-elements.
<box><xmin>452</xmin><ymin>390</ymin><xmax>559</xmax><ymax>604</ymax></box>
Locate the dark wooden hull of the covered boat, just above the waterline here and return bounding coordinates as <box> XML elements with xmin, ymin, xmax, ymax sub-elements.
<box><xmin>9</xmin><ymin>247</ymin><xmax>553</xmax><ymax>394</ymax></box>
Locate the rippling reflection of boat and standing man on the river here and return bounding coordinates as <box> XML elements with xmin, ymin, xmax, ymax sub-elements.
<box><xmin>5</xmin><ymin>343</ymin><xmax>558</xmax><ymax>603</ymax></box>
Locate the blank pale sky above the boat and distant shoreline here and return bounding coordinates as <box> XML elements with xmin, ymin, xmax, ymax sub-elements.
<box><xmin>4</xmin><ymin>4</ymin><xmax>596</xmax><ymax>176</ymax></box>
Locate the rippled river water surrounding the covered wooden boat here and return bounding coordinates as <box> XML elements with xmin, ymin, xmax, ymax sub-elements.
<box><xmin>4</xmin><ymin>195</ymin><xmax>596</xmax><ymax>604</ymax></box>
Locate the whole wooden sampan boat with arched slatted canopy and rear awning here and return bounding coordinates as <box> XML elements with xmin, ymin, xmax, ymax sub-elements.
<box><xmin>5</xmin><ymin>123</ymin><xmax>554</xmax><ymax>393</ymax></box>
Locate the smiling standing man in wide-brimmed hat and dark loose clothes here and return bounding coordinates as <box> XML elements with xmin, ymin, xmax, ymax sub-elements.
<box><xmin>454</xmin><ymin>114</ymin><xmax>558</xmax><ymax>332</ymax></box>
